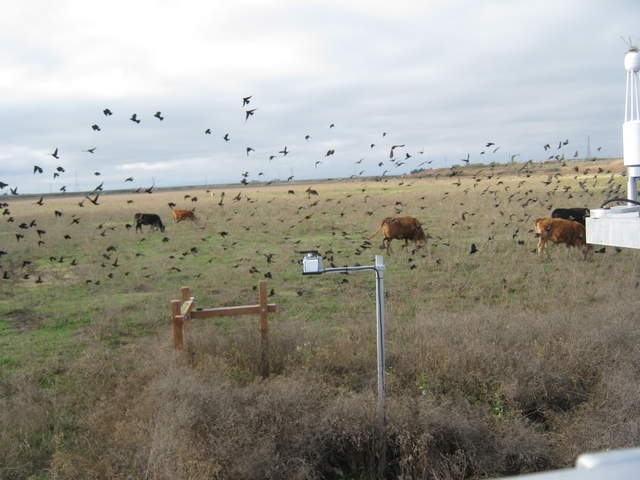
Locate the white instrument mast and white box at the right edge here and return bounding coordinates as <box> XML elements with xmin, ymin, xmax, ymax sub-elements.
<box><xmin>586</xmin><ymin>47</ymin><xmax>640</xmax><ymax>248</ymax></box>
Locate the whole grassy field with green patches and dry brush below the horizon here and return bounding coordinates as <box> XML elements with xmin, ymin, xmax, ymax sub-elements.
<box><xmin>0</xmin><ymin>161</ymin><xmax>640</xmax><ymax>479</ymax></box>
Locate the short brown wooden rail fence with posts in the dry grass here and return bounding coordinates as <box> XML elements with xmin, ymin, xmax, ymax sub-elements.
<box><xmin>171</xmin><ymin>280</ymin><xmax>277</xmax><ymax>377</ymax></box>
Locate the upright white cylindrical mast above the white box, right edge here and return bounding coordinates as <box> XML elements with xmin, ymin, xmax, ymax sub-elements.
<box><xmin>622</xmin><ymin>47</ymin><xmax>640</xmax><ymax>200</ymax></box>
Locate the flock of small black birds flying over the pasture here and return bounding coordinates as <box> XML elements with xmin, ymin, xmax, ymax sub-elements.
<box><xmin>0</xmin><ymin>96</ymin><xmax>622</xmax><ymax>288</ymax></box>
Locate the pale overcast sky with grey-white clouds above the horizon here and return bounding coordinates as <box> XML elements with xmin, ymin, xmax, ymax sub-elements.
<box><xmin>0</xmin><ymin>0</ymin><xmax>640</xmax><ymax>193</ymax></box>
